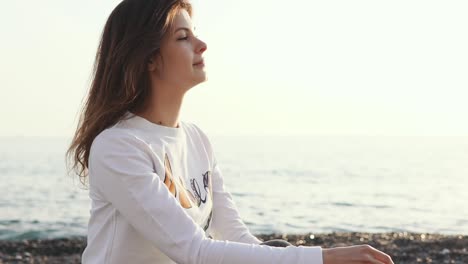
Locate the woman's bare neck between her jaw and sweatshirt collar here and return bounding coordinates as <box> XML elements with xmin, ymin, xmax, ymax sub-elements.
<box><xmin>136</xmin><ymin>83</ymin><xmax>184</xmax><ymax>127</ymax></box>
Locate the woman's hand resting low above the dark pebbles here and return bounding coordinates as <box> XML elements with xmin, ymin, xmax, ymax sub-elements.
<box><xmin>322</xmin><ymin>245</ymin><xmax>393</xmax><ymax>264</ymax></box>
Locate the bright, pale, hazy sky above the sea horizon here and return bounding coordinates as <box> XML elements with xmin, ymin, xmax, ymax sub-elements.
<box><xmin>0</xmin><ymin>0</ymin><xmax>468</xmax><ymax>137</ymax></box>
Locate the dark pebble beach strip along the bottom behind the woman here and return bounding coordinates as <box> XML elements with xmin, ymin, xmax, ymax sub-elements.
<box><xmin>0</xmin><ymin>232</ymin><xmax>468</xmax><ymax>264</ymax></box>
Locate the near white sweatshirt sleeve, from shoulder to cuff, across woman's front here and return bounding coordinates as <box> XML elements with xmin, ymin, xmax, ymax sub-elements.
<box><xmin>89</xmin><ymin>131</ymin><xmax>323</xmax><ymax>264</ymax></box>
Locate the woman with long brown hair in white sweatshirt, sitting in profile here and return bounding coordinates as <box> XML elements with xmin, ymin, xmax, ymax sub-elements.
<box><xmin>68</xmin><ymin>0</ymin><xmax>392</xmax><ymax>264</ymax></box>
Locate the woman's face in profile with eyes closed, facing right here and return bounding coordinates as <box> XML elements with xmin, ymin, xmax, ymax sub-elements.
<box><xmin>149</xmin><ymin>9</ymin><xmax>207</xmax><ymax>90</ymax></box>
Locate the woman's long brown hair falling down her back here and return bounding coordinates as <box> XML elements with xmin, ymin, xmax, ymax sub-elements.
<box><xmin>66</xmin><ymin>0</ymin><xmax>192</xmax><ymax>186</ymax></box>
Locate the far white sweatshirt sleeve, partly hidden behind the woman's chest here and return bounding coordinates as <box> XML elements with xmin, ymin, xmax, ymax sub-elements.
<box><xmin>207</xmin><ymin>163</ymin><xmax>263</xmax><ymax>244</ymax></box>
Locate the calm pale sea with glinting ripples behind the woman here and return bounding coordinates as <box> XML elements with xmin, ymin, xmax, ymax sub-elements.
<box><xmin>0</xmin><ymin>135</ymin><xmax>468</xmax><ymax>240</ymax></box>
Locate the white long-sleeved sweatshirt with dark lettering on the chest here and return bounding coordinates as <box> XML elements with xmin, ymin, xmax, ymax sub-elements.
<box><xmin>82</xmin><ymin>112</ymin><xmax>323</xmax><ymax>264</ymax></box>
